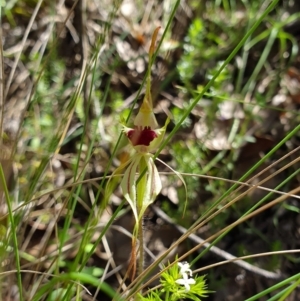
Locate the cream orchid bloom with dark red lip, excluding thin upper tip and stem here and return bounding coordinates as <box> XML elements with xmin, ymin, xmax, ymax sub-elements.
<box><xmin>121</xmin><ymin>102</ymin><xmax>169</xmax><ymax>222</ymax></box>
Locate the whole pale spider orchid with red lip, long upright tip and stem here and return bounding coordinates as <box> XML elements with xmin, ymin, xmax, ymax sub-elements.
<box><xmin>107</xmin><ymin>28</ymin><xmax>170</xmax><ymax>278</ymax></box>
